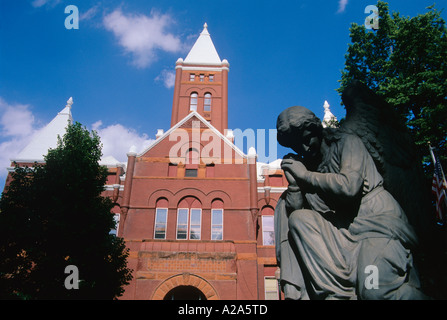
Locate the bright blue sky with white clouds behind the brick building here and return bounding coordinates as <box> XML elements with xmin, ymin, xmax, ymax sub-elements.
<box><xmin>0</xmin><ymin>0</ymin><xmax>447</xmax><ymax>187</ymax></box>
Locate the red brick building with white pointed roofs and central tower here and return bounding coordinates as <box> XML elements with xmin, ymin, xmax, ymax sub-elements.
<box><xmin>6</xmin><ymin>24</ymin><xmax>333</xmax><ymax>300</ymax></box>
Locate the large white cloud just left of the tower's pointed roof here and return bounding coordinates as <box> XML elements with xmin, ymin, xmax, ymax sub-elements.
<box><xmin>103</xmin><ymin>9</ymin><xmax>182</xmax><ymax>68</ymax></box>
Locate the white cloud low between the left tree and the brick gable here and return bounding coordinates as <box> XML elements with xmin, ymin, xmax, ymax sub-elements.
<box><xmin>92</xmin><ymin>120</ymin><xmax>155</xmax><ymax>162</ymax></box>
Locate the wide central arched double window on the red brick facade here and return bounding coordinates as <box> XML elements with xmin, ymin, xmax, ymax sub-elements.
<box><xmin>177</xmin><ymin>197</ymin><xmax>202</xmax><ymax>240</ymax></box>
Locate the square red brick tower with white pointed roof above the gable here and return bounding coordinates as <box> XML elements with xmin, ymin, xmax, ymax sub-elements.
<box><xmin>171</xmin><ymin>23</ymin><xmax>230</xmax><ymax>134</ymax></box>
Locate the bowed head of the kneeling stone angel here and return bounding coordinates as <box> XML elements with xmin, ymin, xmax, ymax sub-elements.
<box><xmin>276</xmin><ymin>106</ymin><xmax>323</xmax><ymax>160</ymax></box>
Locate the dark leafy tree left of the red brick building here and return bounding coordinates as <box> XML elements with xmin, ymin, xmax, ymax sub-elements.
<box><xmin>0</xmin><ymin>123</ymin><xmax>131</xmax><ymax>299</ymax></box>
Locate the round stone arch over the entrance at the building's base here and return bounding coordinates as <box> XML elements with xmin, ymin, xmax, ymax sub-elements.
<box><xmin>152</xmin><ymin>273</ymin><xmax>219</xmax><ymax>300</ymax></box>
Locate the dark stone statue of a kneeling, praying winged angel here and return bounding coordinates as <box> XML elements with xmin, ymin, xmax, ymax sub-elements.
<box><xmin>275</xmin><ymin>82</ymin><xmax>426</xmax><ymax>300</ymax></box>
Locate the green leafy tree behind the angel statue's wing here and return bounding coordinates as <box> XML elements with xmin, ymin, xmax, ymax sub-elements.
<box><xmin>338</xmin><ymin>1</ymin><xmax>447</xmax><ymax>177</ymax></box>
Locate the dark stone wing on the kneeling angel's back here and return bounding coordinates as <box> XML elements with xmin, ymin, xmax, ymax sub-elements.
<box><xmin>340</xmin><ymin>81</ymin><xmax>429</xmax><ymax>233</ymax></box>
